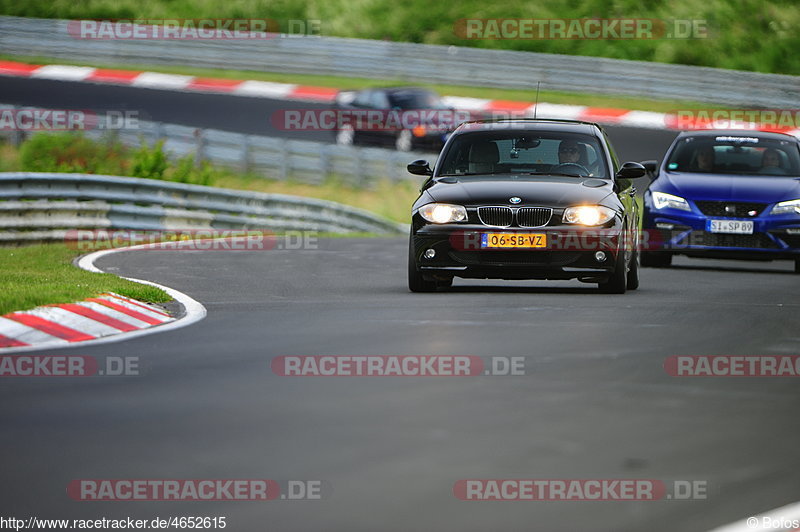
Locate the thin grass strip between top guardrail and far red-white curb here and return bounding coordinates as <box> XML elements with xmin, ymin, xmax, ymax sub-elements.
<box><xmin>0</xmin><ymin>54</ymin><xmax>722</xmax><ymax>113</ymax></box>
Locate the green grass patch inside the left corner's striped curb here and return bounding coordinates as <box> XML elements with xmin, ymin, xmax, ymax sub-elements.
<box><xmin>0</xmin><ymin>244</ymin><xmax>172</xmax><ymax>314</ymax></box>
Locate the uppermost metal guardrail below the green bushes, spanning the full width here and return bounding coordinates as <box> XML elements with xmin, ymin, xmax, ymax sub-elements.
<box><xmin>0</xmin><ymin>17</ymin><xmax>800</xmax><ymax>108</ymax></box>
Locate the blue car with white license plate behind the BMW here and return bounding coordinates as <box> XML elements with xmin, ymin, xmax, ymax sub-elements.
<box><xmin>642</xmin><ymin>130</ymin><xmax>800</xmax><ymax>273</ymax></box>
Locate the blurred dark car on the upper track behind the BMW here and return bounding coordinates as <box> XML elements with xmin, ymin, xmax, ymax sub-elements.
<box><xmin>335</xmin><ymin>87</ymin><xmax>468</xmax><ymax>152</ymax></box>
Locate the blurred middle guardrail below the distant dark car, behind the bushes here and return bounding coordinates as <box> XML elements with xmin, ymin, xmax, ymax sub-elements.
<box><xmin>0</xmin><ymin>104</ymin><xmax>436</xmax><ymax>187</ymax></box>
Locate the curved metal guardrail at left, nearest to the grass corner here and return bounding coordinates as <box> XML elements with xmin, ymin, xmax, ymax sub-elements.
<box><xmin>0</xmin><ymin>172</ymin><xmax>407</xmax><ymax>244</ymax></box>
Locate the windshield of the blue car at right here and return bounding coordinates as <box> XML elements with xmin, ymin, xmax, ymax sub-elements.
<box><xmin>667</xmin><ymin>134</ymin><xmax>800</xmax><ymax>177</ymax></box>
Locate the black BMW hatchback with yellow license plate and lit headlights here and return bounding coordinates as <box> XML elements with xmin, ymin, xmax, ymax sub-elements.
<box><xmin>408</xmin><ymin>119</ymin><xmax>645</xmax><ymax>294</ymax></box>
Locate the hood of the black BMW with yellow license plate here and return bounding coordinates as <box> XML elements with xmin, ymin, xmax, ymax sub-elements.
<box><xmin>427</xmin><ymin>176</ymin><xmax>613</xmax><ymax>207</ymax></box>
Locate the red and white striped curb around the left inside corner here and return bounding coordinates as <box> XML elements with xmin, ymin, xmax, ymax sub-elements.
<box><xmin>0</xmin><ymin>244</ymin><xmax>206</xmax><ymax>354</ymax></box>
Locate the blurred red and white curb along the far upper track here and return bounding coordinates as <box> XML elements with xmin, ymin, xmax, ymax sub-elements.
<box><xmin>0</xmin><ymin>61</ymin><xmax>800</xmax><ymax>136</ymax></box>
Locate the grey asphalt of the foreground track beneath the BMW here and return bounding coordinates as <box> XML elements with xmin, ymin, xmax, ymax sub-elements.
<box><xmin>0</xmin><ymin>238</ymin><xmax>800</xmax><ymax>532</ymax></box>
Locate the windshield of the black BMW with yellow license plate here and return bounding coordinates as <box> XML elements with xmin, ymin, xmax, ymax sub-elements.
<box><xmin>438</xmin><ymin>130</ymin><xmax>609</xmax><ymax>178</ymax></box>
